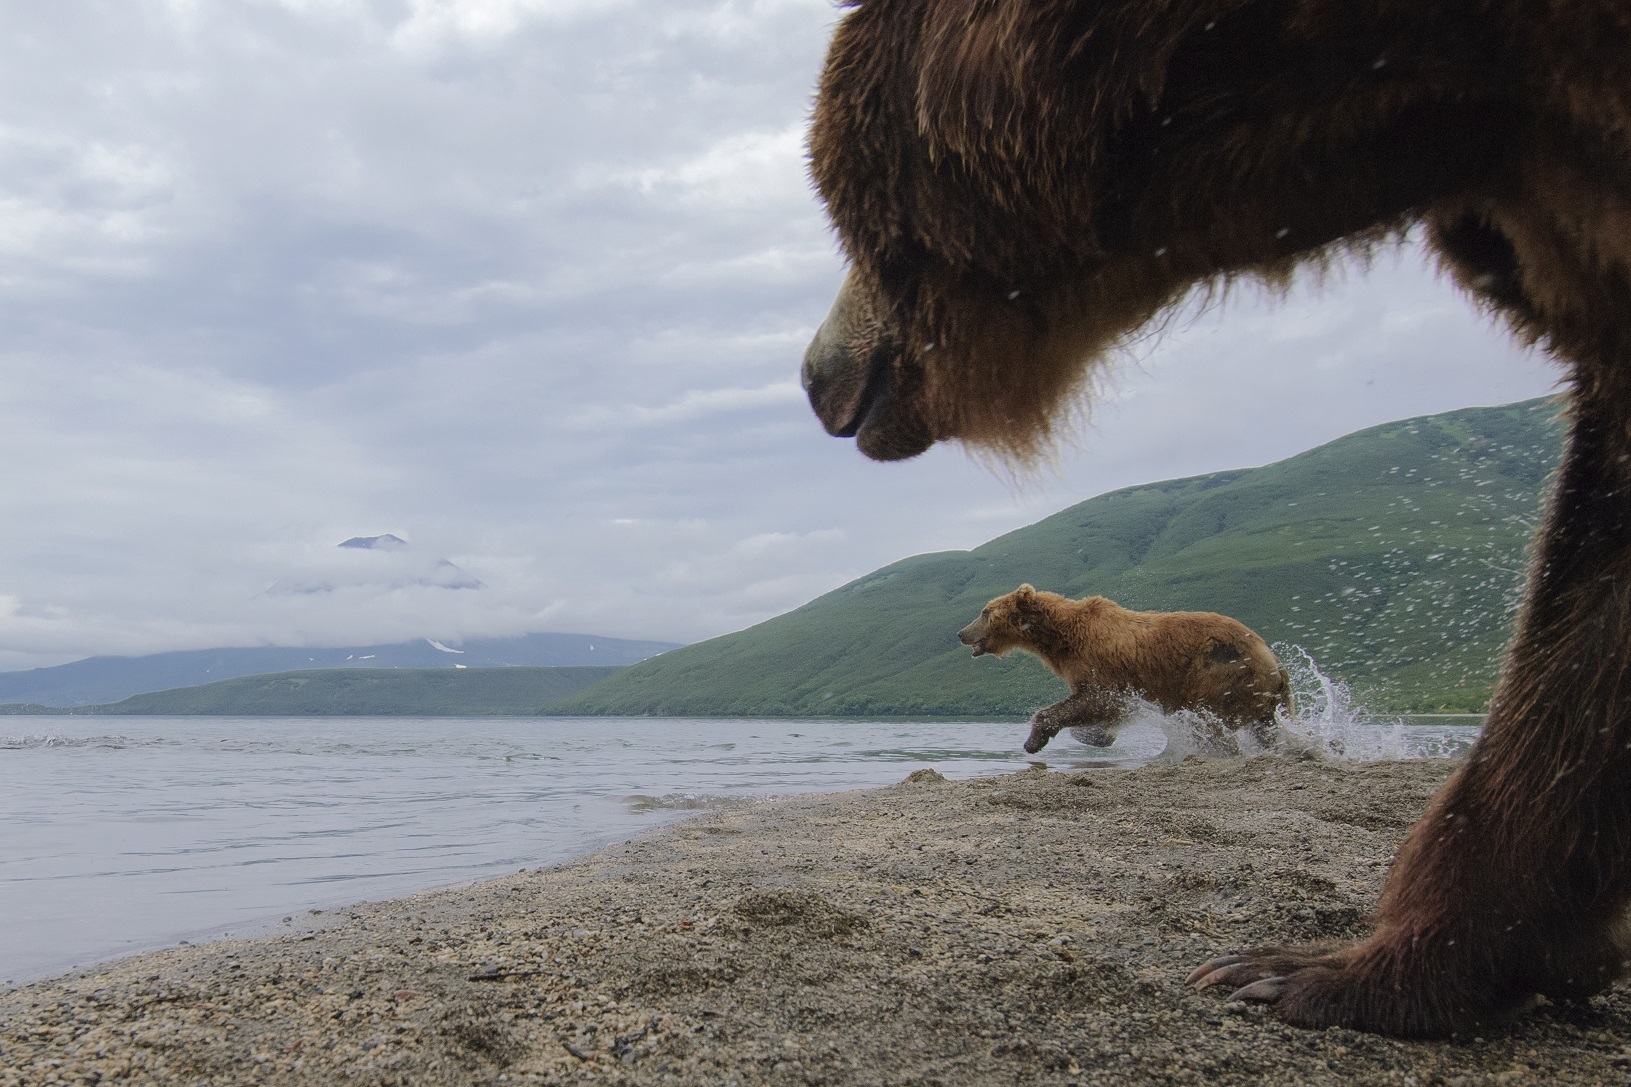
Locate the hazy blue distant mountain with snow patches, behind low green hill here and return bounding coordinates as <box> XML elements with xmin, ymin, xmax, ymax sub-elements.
<box><xmin>0</xmin><ymin>633</ymin><xmax>678</xmax><ymax>707</ymax></box>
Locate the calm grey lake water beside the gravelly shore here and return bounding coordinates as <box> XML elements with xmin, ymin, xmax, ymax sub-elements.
<box><xmin>0</xmin><ymin>717</ymin><xmax>1476</xmax><ymax>983</ymax></box>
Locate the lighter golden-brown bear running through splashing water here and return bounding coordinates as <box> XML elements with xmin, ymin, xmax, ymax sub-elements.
<box><xmin>957</xmin><ymin>584</ymin><xmax>1292</xmax><ymax>754</ymax></box>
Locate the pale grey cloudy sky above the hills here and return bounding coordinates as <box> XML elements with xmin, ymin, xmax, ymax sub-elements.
<box><xmin>0</xmin><ymin>0</ymin><xmax>1554</xmax><ymax>668</ymax></box>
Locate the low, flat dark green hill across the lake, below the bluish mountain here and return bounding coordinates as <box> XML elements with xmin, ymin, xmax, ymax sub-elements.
<box><xmin>0</xmin><ymin>668</ymin><xmax>620</xmax><ymax>717</ymax></box>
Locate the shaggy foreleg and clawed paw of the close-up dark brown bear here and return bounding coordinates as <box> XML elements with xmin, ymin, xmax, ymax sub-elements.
<box><xmin>1191</xmin><ymin>383</ymin><xmax>1631</xmax><ymax>1036</ymax></box>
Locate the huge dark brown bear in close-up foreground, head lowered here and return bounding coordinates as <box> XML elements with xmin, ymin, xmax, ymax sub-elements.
<box><xmin>804</xmin><ymin>0</ymin><xmax>1631</xmax><ymax>1035</ymax></box>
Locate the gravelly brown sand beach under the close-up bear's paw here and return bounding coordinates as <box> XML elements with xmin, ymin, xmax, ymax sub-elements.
<box><xmin>0</xmin><ymin>759</ymin><xmax>1631</xmax><ymax>1087</ymax></box>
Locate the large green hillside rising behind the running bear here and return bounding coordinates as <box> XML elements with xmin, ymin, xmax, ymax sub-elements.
<box><xmin>551</xmin><ymin>400</ymin><xmax>1562</xmax><ymax>717</ymax></box>
